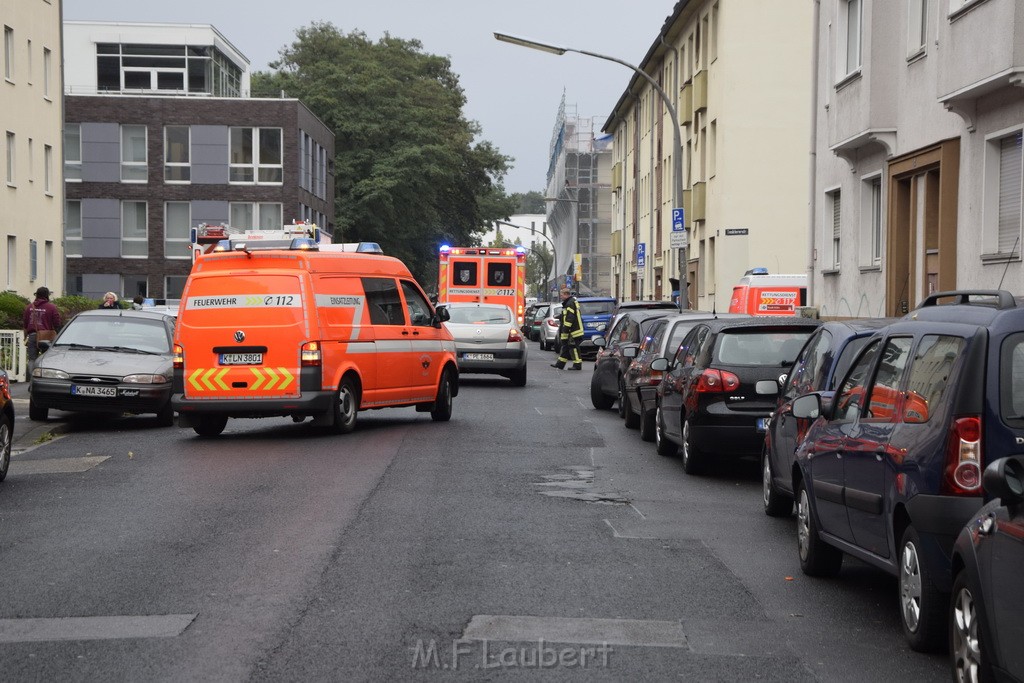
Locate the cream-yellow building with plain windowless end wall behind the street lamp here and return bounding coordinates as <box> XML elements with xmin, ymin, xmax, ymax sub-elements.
<box><xmin>604</xmin><ymin>0</ymin><xmax>814</xmax><ymax>310</ymax></box>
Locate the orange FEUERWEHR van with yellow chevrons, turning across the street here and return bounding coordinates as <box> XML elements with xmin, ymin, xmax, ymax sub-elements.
<box><xmin>171</xmin><ymin>240</ymin><xmax>459</xmax><ymax>436</ymax></box>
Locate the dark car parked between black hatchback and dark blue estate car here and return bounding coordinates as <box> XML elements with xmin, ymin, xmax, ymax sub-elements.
<box><xmin>761</xmin><ymin>318</ymin><xmax>894</xmax><ymax>517</ymax></box>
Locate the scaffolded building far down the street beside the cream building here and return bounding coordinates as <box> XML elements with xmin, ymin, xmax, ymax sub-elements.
<box><xmin>545</xmin><ymin>94</ymin><xmax>611</xmax><ymax>296</ymax></box>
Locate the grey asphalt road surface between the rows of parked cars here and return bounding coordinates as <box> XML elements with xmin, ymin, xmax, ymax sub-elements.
<box><xmin>0</xmin><ymin>345</ymin><xmax>948</xmax><ymax>682</ymax></box>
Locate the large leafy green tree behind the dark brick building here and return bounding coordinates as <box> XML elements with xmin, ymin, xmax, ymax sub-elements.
<box><xmin>252</xmin><ymin>23</ymin><xmax>515</xmax><ymax>290</ymax></box>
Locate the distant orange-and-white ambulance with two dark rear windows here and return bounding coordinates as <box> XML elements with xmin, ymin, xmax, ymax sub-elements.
<box><xmin>437</xmin><ymin>245</ymin><xmax>526</xmax><ymax>328</ymax></box>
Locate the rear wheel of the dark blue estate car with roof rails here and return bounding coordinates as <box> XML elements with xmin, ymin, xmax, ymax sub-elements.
<box><xmin>899</xmin><ymin>526</ymin><xmax>948</xmax><ymax>652</ymax></box>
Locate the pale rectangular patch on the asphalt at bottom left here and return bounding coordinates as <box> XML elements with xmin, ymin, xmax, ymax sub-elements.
<box><xmin>0</xmin><ymin>614</ymin><xmax>198</xmax><ymax>643</ymax></box>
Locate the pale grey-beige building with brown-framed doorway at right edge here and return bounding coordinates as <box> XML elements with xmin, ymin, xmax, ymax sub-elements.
<box><xmin>808</xmin><ymin>0</ymin><xmax>1024</xmax><ymax>317</ymax></box>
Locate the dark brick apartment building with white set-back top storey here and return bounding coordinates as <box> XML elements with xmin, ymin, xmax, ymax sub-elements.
<box><xmin>63</xmin><ymin>22</ymin><xmax>334</xmax><ymax>298</ymax></box>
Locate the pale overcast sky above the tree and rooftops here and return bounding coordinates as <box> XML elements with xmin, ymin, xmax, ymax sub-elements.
<box><xmin>63</xmin><ymin>0</ymin><xmax>675</xmax><ymax>193</ymax></box>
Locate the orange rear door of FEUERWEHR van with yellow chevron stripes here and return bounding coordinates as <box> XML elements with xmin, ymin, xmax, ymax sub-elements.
<box><xmin>177</xmin><ymin>271</ymin><xmax>314</xmax><ymax>400</ymax></box>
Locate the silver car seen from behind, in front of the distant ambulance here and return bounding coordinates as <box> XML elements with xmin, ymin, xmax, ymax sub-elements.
<box><xmin>444</xmin><ymin>302</ymin><xmax>526</xmax><ymax>387</ymax></box>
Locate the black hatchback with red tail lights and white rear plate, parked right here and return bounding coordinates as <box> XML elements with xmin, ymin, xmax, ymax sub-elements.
<box><xmin>651</xmin><ymin>316</ymin><xmax>820</xmax><ymax>474</ymax></box>
